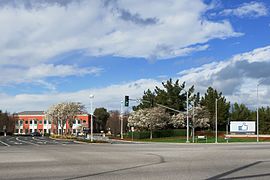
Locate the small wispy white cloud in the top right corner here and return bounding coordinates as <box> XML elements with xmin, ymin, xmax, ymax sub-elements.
<box><xmin>220</xmin><ymin>1</ymin><xmax>268</xmax><ymax>18</ymax></box>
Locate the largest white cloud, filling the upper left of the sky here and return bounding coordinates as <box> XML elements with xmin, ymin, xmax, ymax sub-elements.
<box><xmin>0</xmin><ymin>0</ymin><xmax>241</xmax><ymax>66</ymax></box>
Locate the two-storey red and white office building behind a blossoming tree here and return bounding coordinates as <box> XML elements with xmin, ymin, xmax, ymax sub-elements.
<box><xmin>14</xmin><ymin>111</ymin><xmax>91</xmax><ymax>134</ymax></box>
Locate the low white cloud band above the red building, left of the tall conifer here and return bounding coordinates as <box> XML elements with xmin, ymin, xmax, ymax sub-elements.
<box><xmin>0</xmin><ymin>79</ymin><xmax>160</xmax><ymax>112</ymax></box>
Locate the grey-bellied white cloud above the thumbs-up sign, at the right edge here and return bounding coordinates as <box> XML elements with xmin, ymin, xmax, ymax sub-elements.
<box><xmin>179</xmin><ymin>46</ymin><xmax>270</xmax><ymax>107</ymax></box>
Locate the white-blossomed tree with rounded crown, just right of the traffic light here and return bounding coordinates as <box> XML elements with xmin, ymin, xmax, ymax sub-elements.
<box><xmin>128</xmin><ymin>107</ymin><xmax>169</xmax><ymax>139</ymax></box>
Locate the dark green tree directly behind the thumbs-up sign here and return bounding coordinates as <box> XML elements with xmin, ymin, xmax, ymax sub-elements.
<box><xmin>231</xmin><ymin>103</ymin><xmax>251</xmax><ymax>120</ymax></box>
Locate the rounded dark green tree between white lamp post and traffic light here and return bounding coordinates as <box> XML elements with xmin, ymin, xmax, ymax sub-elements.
<box><xmin>94</xmin><ymin>107</ymin><xmax>110</xmax><ymax>131</ymax></box>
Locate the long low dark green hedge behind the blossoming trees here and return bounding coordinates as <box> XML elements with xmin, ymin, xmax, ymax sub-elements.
<box><xmin>127</xmin><ymin>129</ymin><xmax>186</xmax><ymax>139</ymax></box>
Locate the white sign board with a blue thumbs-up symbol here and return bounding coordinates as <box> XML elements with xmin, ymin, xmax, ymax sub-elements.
<box><xmin>230</xmin><ymin>121</ymin><xmax>256</xmax><ymax>133</ymax></box>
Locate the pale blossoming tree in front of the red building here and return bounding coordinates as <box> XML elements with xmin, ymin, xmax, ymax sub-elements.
<box><xmin>46</xmin><ymin>102</ymin><xmax>84</xmax><ymax>135</ymax></box>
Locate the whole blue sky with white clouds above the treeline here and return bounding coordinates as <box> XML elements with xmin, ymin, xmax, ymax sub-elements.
<box><xmin>0</xmin><ymin>0</ymin><xmax>270</xmax><ymax>113</ymax></box>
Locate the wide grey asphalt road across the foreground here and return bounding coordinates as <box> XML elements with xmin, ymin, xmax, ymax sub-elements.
<box><xmin>0</xmin><ymin>137</ymin><xmax>270</xmax><ymax>180</ymax></box>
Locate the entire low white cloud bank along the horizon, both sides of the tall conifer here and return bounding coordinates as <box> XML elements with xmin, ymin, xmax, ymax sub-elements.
<box><xmin>0</xmin><ymin>46</ymin><xmax>270</xmax><ymax>112</ymax></box>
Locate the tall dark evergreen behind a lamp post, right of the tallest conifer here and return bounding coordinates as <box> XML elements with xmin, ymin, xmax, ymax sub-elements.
<box><xmin>200</xmin><ymin>87</ymin><xmax>230</xmax><ymax>128</ymax></box>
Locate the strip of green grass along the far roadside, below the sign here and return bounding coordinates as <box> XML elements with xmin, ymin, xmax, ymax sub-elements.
<box><xmin>134</xmin><ymin>136</ymin><xmax>270</xmax><ymax>143</ymax></box>
